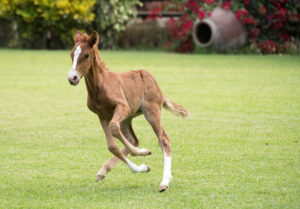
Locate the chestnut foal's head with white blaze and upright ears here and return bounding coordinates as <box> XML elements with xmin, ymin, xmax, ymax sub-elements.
<box><xmin>68</xmin><ymin>30</ymin><xmax>98</xmax><ymax>85</ymax></box>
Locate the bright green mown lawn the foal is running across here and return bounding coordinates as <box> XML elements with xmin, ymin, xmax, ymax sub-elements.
<box><xmin>0</xmin><ymin>50</ymin><xmax>300</xmax><ymax>209</ymax></box>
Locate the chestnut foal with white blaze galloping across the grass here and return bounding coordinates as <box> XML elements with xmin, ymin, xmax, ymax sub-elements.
<box><xmin>68</xmin><ymin>31</ymin><xmax>189</xmax><ymax>192</ymax></box>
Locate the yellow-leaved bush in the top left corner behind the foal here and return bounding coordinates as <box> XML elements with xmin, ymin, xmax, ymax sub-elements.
<box><xmin>0</xmin><ymin>0</ymin><xmax>95</xmax><ymax>48</ymax></box>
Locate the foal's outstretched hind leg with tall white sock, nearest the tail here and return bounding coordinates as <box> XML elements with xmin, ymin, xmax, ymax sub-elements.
<box><xmin>143</xmin><ymin>103</ymin><xmax>172</xmax><ymax>192</ymax></box>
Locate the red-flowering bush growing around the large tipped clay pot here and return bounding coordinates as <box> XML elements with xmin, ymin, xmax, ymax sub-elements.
<box><xmin>165</xmin><ymin>0</ymin><xmax>300</xmax><ymax>53</ymax></box>
